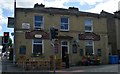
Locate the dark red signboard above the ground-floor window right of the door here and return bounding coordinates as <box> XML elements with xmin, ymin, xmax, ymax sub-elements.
<box><xmin>79</xmin><ymin>32</ymin><xmax>100</xmax><ymax>41</ymax></box>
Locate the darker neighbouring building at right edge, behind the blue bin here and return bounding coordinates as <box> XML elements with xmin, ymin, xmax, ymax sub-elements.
<box><xmin>101</xmin><ymin>11</ymin><xmax>120</xmax><ymax>55</ymax></box>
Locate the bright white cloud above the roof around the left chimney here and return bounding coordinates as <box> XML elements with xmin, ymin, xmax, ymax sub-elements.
<box><xmin>16</xmin><ymin>0</ymin><xmax>69</xmax><ymax>8</ymax></box>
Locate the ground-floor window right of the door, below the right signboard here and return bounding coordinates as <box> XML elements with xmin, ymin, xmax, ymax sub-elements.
<box><xmin>85</xmin><ymin>40</ymin><xmax>94</xmax><ymax>55</ymax></box>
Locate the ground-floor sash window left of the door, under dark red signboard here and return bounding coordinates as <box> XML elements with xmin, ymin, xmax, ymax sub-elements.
<box><xmin>33</xmin><ymin>39</ymin><xmax>43</xmax><ymax>54</ymax></box>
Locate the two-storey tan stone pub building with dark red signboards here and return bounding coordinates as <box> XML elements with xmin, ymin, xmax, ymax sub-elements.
<box><xmin>14</xmin><ymin>4</ymin><xmax>109</xmax><ymax>64</ymax></box>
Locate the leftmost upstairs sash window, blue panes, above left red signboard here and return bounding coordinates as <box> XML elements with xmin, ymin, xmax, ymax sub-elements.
<box><xmin>34</xmin><ymin>16</ymin><xmax>43</xmax><ymax>29</ymax></box>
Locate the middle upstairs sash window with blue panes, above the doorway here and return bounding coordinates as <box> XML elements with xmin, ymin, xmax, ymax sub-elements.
<box><xmin>60</xmin><ymin>17</ymin><xmax>69</xmax><ymax>31</ymax></box>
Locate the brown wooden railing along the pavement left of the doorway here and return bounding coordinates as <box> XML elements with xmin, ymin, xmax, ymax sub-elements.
<box><xmin>17</xmin><ymin>59</ymin><xmax>62</xmax><ymax>71</ymax></box>
